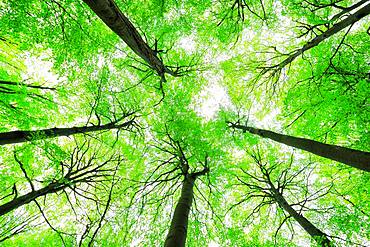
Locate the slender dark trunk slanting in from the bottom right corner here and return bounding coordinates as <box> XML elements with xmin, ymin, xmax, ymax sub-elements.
<box><xmin>270</xmin><ymin>184</ymin><xmax>332</xmax><ymax>247</ymax></box>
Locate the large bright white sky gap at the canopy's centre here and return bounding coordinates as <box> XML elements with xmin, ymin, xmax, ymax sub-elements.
<box><xmin>195</xmin><ymin>83</ymin><xmax>232</xmax><ymax>121</ymax></box>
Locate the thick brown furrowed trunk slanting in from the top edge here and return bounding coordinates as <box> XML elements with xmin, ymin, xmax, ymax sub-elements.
<box><xmin>83</xmin><ymin>0</ymin><xmax>170</xmax><ymax>77</ymax></box>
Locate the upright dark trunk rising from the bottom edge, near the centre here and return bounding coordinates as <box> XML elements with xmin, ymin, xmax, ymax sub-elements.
<box><xmin>164</xmin><ymin>176</ymin><xmax>196</xmax><ymax>247</ymax></box>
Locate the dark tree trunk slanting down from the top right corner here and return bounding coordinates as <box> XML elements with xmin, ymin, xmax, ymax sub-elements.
<box><xmin>274</xmin><ymin>4</ymin><xmax>370</xmax><ymax>71</ymax></box>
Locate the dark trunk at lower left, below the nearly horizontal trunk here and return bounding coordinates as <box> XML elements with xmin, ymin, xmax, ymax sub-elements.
<box><xmin>0</xmin><ymin>182</ymin><xmax>66</xmax><ymax>216</ymax></box>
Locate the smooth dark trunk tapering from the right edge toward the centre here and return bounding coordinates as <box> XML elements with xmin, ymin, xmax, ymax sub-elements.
<box><xmin>231</xmin><ymin>123</ymin><xmax>370</xmax><ymax>172</ymax></box>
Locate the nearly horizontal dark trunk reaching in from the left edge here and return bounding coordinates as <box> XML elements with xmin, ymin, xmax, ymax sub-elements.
<box><xmin>0</xmin><ymin>120</ymin><xmax>133</xmax><ymax>146</ymax></box>
